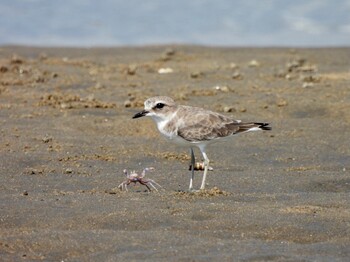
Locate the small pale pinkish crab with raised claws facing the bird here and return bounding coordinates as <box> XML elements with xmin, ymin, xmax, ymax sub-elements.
<box><xmin>118</xmin><ymin>167</ymin><xmax>162</xmax><ymax>191</ymax></box>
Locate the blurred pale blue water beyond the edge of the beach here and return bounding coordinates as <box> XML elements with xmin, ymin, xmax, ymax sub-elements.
<box><xmin>0</xmin><ymin>0</ymin><xmax>350</xmax><ymax>47</ymax></box>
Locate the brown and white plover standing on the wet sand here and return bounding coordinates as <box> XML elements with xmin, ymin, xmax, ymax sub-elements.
<box><xmin>133</xmin><ymin>96</ymin><xmax>271</xmax><ymax>190</ymax></box>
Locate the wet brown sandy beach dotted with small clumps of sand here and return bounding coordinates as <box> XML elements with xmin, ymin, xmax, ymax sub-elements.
<box><xmin>0</xmin><ymin>46</ymin><xmax>350</xmax><ymax>261</ymax></box>
